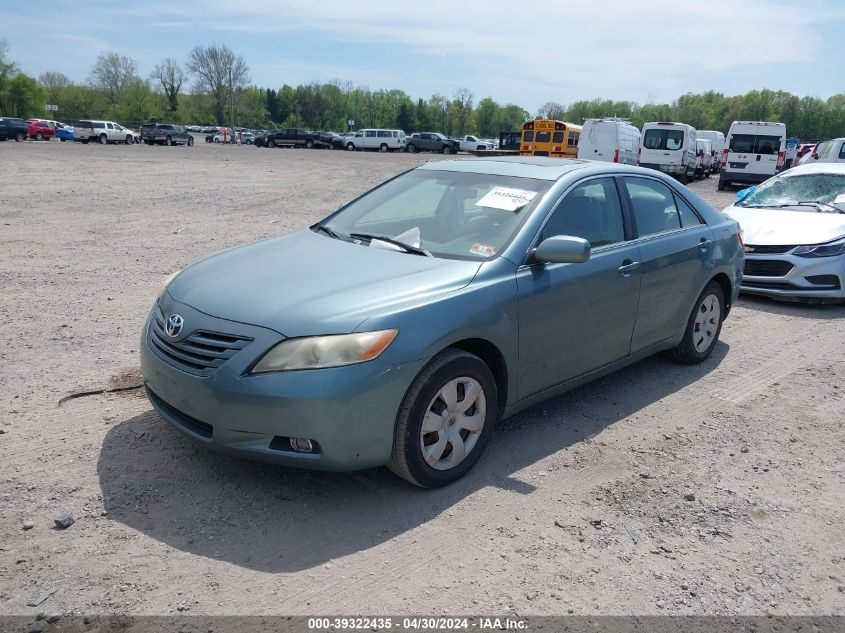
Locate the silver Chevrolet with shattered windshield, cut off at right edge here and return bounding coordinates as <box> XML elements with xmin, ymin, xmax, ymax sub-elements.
<box><xmin>725</xmin><ymin>163</ymin><xmax>845</xmax><ymax>302</ymax></box>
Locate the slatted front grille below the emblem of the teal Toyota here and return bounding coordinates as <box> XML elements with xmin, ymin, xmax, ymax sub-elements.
<box><xmin>150</xmin><ymin>308</ymin><xmax>252</xmax><ymax>376</ymax></box>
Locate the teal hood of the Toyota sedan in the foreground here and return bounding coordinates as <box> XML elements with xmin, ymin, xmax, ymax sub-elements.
<box><xmin>167</xmin><ymin>229</ymin><xmax>481</xmax><ymax>337</ymax></box>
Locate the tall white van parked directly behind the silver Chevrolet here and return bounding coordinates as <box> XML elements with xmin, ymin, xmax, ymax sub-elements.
<box><xmin>719</xmin><ymin>121</ymin><xmax>786</xmax><ymax>191</ymax></box>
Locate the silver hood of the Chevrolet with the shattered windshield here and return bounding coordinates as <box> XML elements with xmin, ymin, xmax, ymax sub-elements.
<box><xmin>724</xmin><ymin>206</ymin><xmax>845</xmax><ymax>246</ymax></box>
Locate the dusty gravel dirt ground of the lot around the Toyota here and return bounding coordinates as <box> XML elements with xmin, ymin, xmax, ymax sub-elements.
<box><xmin>0</xmin><ymin>141</ymin><xmax>845</xmax><ymax>615</ymax></box>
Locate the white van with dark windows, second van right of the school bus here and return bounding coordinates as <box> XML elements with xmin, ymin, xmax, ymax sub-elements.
<box><xmin>639</xmin><ymin>121</ymin><xmax>698</xmax><ymax>181</ymax></box>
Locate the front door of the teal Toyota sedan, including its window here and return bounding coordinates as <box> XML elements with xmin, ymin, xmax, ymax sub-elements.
<box><xmin>517</xmin><ymin>176</ymin><xmax>640</xmax><ymax>398</ymax></box>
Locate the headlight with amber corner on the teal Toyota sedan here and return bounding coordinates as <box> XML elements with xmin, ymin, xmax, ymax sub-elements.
<box><xmin>252</xmin><ymin>330</ymin><xmax>399</xmax><ymax>374</ymax></box>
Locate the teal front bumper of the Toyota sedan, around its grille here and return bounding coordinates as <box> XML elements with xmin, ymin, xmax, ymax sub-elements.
<box><xmin>141</xmin><ymin>295</ymin><xmax>425</xmax><ymax>470</ymax></box>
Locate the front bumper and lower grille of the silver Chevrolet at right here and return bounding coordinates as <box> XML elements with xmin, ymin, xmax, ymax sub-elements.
<box><xmin>742</xmin><ymin>253</ymin><xmax>845</xmax><ymax>302</ymax></box>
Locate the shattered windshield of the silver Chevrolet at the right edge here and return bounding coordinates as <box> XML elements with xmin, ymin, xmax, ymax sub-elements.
<box><xmin>736</xmin><ymin>171</ymin><xmax>845</xmax><ymax>212</ymax></box>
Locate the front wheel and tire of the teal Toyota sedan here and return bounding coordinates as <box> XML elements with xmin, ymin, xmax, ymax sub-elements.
<box><xmin>388</xmin><ymin>349</ymin><xmax>499</xmax><ymax>488</ymax></box>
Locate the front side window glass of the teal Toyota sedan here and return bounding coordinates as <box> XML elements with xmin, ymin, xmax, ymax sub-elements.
<box><xmin>540</xmin><ymin>178</ymin><xmax>625</xmax><ymax>248</ymax></box>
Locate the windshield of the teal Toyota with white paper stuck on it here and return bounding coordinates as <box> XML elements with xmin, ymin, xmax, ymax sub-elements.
<box><xmin>324</xmin><ymin>170</ymin><xmax>552</xmax><ymax>260</ymax></box>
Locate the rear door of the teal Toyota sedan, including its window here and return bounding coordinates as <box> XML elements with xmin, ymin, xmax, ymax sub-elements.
<box><xmin>622</xmin><ymin>176</ymin><xmax>715</xmax><ymax>353</ymax></box>
